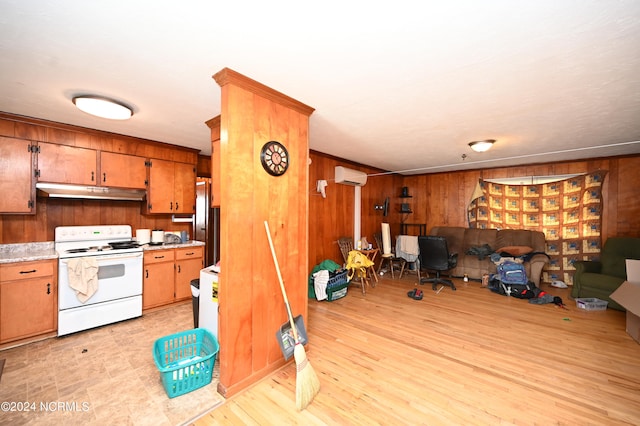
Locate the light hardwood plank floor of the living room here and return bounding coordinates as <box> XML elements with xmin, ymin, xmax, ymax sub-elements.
<box><xmin>195</xmin><ymin>275</ymin><xmax>640</xmax><ymax>426</ymax></box>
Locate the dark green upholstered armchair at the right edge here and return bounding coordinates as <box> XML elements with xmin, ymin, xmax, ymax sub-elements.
<box><xmin>571</xmin><ymin>237</ymin><xmax>640</xmax><ymax>311</ymax></box>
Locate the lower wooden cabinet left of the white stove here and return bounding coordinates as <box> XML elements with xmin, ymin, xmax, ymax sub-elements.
<box><xmin>0</xmin><ymin>259</ymin><xmax>58</xmax><ymax>343</ymax></box>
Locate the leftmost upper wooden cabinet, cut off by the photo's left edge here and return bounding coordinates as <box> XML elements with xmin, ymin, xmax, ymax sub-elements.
<box><xmin>0</xmin><ymin>137</ymin><xmax>35</xmax><ymax>214</ymax></box>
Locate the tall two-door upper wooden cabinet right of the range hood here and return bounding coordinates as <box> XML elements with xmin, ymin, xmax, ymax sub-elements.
<box><xmin>146</xmin><ymin>159</ymin><xmax>196</xmax><ymax>214</ymax></box>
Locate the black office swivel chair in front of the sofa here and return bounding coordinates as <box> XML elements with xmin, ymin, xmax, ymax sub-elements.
<box><xmin>418</xmin><ymin>235</ymin><xmax>458</xmax><ymax>290</ymax></box>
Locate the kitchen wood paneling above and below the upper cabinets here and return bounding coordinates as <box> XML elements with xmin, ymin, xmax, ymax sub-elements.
<box><xmin>0</xmin><ymin>112</ymin><xmax>199</xmax><ymax>244</ymax></box>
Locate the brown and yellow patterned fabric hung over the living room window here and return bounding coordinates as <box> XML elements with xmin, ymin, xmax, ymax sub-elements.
<box><xmin>468</xmin><ymin>170</ymin><xmax>607</xmax><ymax>285</ymax></box>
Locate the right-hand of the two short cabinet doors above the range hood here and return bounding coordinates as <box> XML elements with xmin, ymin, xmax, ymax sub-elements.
<box><xmin>99</xmin><ymin>151</ymin><xmax>147</xmax><ymax>189</ymax></box>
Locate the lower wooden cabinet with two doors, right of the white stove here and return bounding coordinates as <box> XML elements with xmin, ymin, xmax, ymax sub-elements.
<box><xmin>142</xmin><ymin>246</ymin><xmax>204</xmax><ymax>309</ymax></box>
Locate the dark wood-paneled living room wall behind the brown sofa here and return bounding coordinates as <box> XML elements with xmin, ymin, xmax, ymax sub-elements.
<box><xmin>309</xmin><ymin>151</ymin><xmax>640</xmax><ymax>268</ymax></box>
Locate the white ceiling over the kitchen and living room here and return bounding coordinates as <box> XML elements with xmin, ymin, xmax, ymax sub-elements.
<box><xmin>0</xmin><ymin>0</ymin><xmax>640</xmax><ymax>174</ymax></box>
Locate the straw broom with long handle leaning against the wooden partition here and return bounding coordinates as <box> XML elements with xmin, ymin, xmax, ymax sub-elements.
<box><xmin>264</xmin><ymin>220</ymin><xmax>320</xmax><ymax>410</ymax></box>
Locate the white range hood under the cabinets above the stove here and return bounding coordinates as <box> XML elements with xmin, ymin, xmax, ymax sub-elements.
<box><xmin>36</xmin><ymin>182</ymin><xmax>147</xmax><ymax>201</ymax></box>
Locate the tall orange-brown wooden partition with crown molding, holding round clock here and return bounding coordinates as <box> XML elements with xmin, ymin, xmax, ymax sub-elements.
<box><xmin>213</xmin><ymin>68</ymin><xmax>314</xmax><ymax>397</ymax></box>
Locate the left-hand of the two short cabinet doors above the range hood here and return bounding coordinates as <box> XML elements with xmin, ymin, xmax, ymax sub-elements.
<box><xmin>38</xmin><ymin>142</ymin><xmax>98</xmax><ymax>186</ymax></box>
